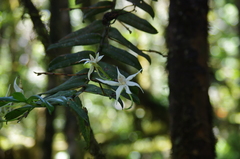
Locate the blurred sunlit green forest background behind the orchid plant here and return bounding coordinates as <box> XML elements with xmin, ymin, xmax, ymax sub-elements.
<box><xmin>0</xmin><ymin>0</ymin><xmax>240</xmax><ymax>159</ymax></box>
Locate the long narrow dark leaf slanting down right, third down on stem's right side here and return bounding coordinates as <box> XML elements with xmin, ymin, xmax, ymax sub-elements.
<box><xmin>108</xmin><ymin>27</ymin><xmax>151</xmax><ymax>63</ymax></box>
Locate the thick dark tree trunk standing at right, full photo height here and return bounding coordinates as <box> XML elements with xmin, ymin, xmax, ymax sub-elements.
<box><xmin>167</xmin><ymin>0</ymin><xmax>215</xmax><ymax>159</ymax></box>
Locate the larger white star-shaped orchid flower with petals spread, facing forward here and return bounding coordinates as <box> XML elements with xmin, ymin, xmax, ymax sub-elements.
<box><xmin>97</xmin><ymin>68</ymin><xmax>143</xmax><ymax>107</ymax></box>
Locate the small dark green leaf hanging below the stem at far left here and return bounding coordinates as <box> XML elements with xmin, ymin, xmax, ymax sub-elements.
<box><xmin>5</xmin><ymin>106</ymin><xmax>34</xmax><ymax>121</ymax></box>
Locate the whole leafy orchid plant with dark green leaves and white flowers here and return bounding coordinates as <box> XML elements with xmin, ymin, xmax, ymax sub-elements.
<box><xmin>0</xmin><ymin>0</ymin><xmax>158</xmax><ymax>151</ymax></box>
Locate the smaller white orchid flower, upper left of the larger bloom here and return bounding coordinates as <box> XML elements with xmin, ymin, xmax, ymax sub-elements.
<box><xmin>79</xmin><ymin>53</ymin><xmax>104</xmax><ymax>80</ymax></box>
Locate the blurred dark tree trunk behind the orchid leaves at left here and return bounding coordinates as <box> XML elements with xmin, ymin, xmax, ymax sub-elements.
<box><xmin>42</xmin><ymin>0</ymin><xmax>72</xmax><ymax>159</ymax></box>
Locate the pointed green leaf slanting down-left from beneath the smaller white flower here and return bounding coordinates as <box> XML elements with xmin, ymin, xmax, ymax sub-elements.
<box><xmin>42</xmin><ymin>69</ymin><xmax>89</xmax><ymax>95</ymax></box>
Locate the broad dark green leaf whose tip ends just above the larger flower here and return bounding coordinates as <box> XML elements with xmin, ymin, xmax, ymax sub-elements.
<box><xmin>102</xmin><ymin>45</ymin><xmax>142</xmax><ymax>70</ymax></box>
